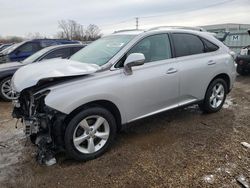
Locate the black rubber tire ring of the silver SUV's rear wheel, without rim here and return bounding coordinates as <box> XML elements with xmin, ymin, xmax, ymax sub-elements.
<box><xmin>203</xmin><ymin>78</ymin><xmax>228</xmax><ymax>113</ymax></box>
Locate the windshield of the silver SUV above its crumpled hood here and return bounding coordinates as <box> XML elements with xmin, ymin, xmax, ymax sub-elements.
<box><xmin>70</xmin><ymin>35</ymin><xmax>135</xmax><ymax>66</ymax></box>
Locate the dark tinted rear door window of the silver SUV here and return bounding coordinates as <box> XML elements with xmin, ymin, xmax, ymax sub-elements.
<box><xmin>173</xmin><ymin>33</ymin><xmax>205</xmax><ymax>57</ymax></box>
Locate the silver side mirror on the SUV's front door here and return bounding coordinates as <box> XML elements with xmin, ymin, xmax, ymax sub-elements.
<box><xmin>124</xmin><ymin>53</ymin><xmax>145</xmax><ymax>75</ymax></box>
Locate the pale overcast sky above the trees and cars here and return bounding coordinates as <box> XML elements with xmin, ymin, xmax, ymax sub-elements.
<box><xmin>0</xmin><ymin>0</ymin><xmax>250</xmax><ymax>36</ymax></box>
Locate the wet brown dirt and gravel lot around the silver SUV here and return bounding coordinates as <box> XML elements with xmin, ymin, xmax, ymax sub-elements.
<box><xmin>0</xmin><ymin>76</ymin><xmax>250</xmax><ymax>188</ymax></box>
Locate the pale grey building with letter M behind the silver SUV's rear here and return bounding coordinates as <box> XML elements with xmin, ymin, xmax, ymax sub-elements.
<box><xmin>201</xmin><ymin>23</ymin><xmax>250</xmax><ymax>53</ymax></box>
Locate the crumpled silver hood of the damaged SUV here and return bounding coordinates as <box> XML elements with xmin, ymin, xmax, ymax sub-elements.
<box><xmin>12</xmin><ymin>59</ymin><xmax>101</xmax><ymax>92</ymax></box>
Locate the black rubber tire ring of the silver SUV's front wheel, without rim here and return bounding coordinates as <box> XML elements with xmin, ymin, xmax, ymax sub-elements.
<box><xmin>64</xmin><ymin>107</ymin><xmax>116</xmax><ymax>161</ymax></box>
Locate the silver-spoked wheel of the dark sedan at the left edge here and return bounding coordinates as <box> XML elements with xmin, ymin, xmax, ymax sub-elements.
<box><xmin>0</xmin><ymin>77</ymin><xmax>16</xmax><ymax>101</ymax></box>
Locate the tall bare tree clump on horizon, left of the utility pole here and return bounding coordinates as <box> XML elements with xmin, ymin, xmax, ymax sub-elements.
<box><xmin>57</xmin><ymin>20</ymin><xmax>101</xmax><ymax>41</ymax></box>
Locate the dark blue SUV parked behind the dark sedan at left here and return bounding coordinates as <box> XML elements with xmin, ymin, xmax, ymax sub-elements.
<box><xmin>0</xmin><ymin>39</ymin><xmax>79</xmax><ymax>64</ymax></box>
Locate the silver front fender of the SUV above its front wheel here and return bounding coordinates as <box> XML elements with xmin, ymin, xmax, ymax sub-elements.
<box><xmin>45</xmin><ymin>71</ymin><xmax>126</xmax><ymax>123</ymax></box>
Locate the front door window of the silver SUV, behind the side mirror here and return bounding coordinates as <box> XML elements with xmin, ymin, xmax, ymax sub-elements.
<box><xmin>115</xmin><ymin>34</ymin><xmax>172</xmax><ymax>67</ymax></box>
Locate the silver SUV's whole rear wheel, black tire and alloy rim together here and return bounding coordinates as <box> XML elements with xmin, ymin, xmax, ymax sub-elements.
<box><xmin>199</xmin><ymin>78</ymin><xmax>228</xmax><ymax>113</ymax></box>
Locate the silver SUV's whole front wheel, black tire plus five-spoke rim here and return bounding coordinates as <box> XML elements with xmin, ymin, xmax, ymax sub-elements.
<box><xmin>64</xmin><ymin>107</ymin><xmax>117</xmax><ymax>161</ymax></box>
